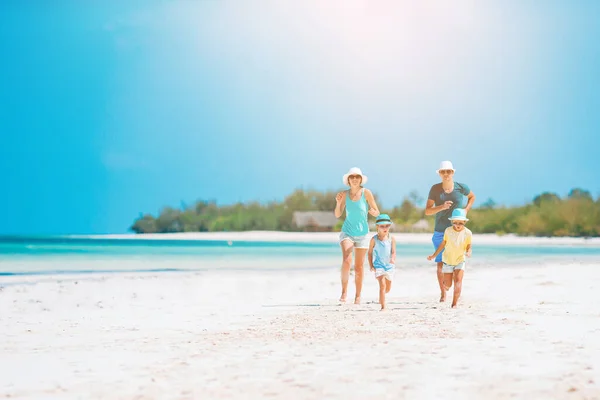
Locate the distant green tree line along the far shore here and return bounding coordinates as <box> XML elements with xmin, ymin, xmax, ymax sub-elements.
<box><xmin>130</xmin><ymin>189</ymin><xmax>600</xmax><ymax>237</ymax></box>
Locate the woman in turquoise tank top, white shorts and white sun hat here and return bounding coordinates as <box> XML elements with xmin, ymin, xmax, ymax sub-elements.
<box><xmin>334</xmin><ymin>167</ymin><xmax>379</xmax><ymax>304</ymax></box>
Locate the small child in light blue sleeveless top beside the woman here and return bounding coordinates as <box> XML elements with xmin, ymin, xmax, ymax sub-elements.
<box><xmin>369</xmin><ymin>214</ymin><xmax>396</xmax><ymax>311</ymax></box>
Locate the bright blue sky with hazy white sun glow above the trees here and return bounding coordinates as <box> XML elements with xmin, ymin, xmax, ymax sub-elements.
<box><xmin>0</xmin><ymin>0</ymin><xmax>600</xmax><ymax>234</ymax></box>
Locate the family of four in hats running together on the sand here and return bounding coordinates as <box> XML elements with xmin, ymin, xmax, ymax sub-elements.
<box><xmin>334</xmin><ymin>161</ymin><xmax>475</xmax><ymax>310</ymax></box>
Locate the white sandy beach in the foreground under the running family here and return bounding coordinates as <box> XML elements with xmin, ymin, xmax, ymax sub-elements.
<box><xmin>0</xmin><ymin>264</ymin><xmax>600</xmax><ymax>399</ymax></box>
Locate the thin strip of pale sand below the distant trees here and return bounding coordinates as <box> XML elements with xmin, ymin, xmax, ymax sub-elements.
<box><xmin>69</xmin><ymin>231</ymin><xmax>600</xmax><ymax>247</ymax></box>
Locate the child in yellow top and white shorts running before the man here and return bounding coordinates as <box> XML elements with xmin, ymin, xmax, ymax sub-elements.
<box><xmin>427</xmin><ymin>208</ymin><xmax>473</xmax><ymax>308</ymax></box>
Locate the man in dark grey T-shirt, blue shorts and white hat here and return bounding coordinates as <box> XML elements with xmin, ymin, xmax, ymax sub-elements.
<box><xmin>425</xmin><ymin>161</ymin><xmax>475</xmax><ymax>302</ymax></box>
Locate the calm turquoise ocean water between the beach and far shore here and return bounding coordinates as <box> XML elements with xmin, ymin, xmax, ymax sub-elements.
<box><xmin>0</xmin><ymin>237</ymin><xmax>600</xmax><ymax>276</ymax></box>
